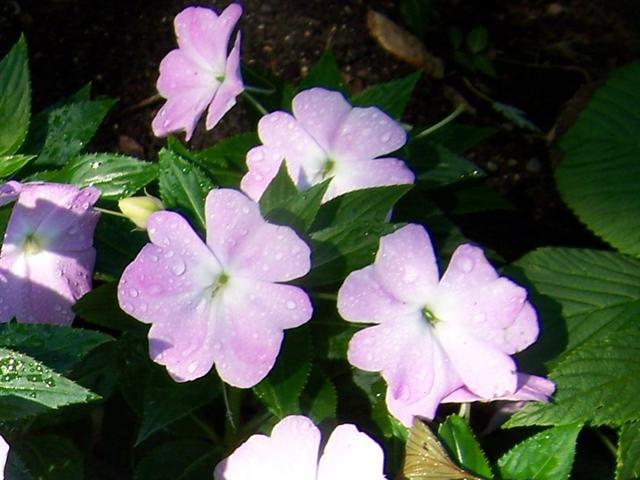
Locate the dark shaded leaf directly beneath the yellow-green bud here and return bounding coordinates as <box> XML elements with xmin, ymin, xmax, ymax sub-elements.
<box><xmin>94</xmin><ymin>214</ymin><xmax>149</xmax><ymax>279</ymax></box>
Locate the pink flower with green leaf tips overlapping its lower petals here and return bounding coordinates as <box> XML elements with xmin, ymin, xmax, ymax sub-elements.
<box><xmin>240</xmin><ymin>88</ymin><xmax>415</xmax><ymax>202</ymax></box>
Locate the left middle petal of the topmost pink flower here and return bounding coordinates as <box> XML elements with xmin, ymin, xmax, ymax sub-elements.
<box><xmin>156</xmin><ymin>49</ymin><xmax>217</xmax><ymax>98</ymax></box>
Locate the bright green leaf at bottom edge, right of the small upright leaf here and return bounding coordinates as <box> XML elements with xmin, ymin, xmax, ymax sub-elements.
<box><xmin>497</xmin><ymin>424</ymin><xmax>582</xmax><ymax>480</ymax></box>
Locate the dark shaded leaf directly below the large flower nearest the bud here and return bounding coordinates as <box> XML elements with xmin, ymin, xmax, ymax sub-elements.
<box><xmin>136</xmin><ymin>368</ymin><xmax>221</xmax><ymax>444</ymax></box>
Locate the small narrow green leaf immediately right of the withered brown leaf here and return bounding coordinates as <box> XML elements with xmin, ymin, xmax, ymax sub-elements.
<box><xmin>438</xmin><ymin>415</ymin><xmax>493</xmax><ymax>478</ymax></box>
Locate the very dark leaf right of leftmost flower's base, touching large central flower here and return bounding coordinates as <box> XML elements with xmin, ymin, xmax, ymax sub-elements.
<box><xmin>73</xmin><ymin>282</ymin><xmax>143</xmax><ymax>330</ymax></box>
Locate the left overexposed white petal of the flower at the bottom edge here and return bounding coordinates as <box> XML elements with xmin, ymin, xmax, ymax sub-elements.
<box><xmin>214</xmin><ymin>415</ymin><xmax>320</xmax><ymax>480</ymax></box>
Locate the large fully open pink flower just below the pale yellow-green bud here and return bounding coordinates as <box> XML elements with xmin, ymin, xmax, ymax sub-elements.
<box><xmin>118</xmin><ymin>189</ymin><xmax>313</xmax><ymax>388</ymax></box>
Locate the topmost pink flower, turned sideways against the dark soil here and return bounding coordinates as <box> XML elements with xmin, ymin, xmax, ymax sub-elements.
<box><xmin>151</xmin><ymin>3</ymin><xmax>244</xmax><ymax>140</ymax></box>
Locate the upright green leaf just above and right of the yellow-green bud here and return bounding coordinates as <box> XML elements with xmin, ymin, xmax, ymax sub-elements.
<box><xmin>159</xmin><ymin>149</ymin><xmax>214</xmax><ymax>231</ymax></box>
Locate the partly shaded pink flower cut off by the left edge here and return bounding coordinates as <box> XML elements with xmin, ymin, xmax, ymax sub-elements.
<box><xmin>0</xmin><ymin>182</ymin><xmax>100</xmax><ymax>325</ymax></box>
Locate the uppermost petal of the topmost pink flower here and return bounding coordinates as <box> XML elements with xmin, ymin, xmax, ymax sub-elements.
<box><xmin>174</xmin><ymin>3</ymin><xmax>242</xmax><ymax>70</ymax></box>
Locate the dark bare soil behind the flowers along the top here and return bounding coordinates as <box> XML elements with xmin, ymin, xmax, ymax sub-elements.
<box><xmin>0</xmin><ymin>0</ymin><xmax>640</xmax><ymax>258</ymax></box>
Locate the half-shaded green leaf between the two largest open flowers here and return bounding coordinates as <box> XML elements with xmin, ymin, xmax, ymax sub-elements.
<box><xmin>303</xmin><ymin>221</ymin><xmax>402</xmax><ymax>287</ymax></box>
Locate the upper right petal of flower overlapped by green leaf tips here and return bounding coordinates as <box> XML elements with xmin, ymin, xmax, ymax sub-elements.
<box><xmin>330</xmin><ymin>107</ymin><xmax>407</xmax><ymax>162</ymax></box>
